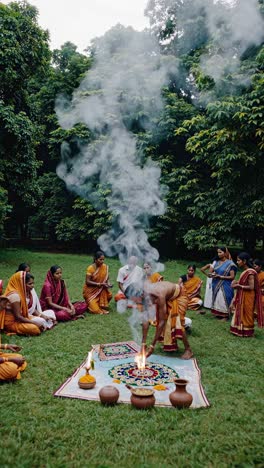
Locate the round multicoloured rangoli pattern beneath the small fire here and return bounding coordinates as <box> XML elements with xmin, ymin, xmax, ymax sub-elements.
<box><xmin>108</xmin><ymin>362</ymin><xmax>179</xmax><ymax>386</ymax></box>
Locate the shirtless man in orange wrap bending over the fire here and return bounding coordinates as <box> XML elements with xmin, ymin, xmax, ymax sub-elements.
<box><xmin>142</xmin><ymin>281</ymin><xmax>193</xmax><ymax>359</ymax></box>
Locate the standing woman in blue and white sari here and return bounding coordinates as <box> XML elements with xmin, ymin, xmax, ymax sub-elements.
<box><xmin>209</xmin><ymin>247</ymin><xmax>237</xmax><ymax>320</ymax></box>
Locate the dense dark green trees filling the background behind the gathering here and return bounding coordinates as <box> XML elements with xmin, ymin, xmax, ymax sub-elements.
<box><xmin>0</xmin><ymin>0</ymin><xmax>264</xmax><ymax>255</ymax></box>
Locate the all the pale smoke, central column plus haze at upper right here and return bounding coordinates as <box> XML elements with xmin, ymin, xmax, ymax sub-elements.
<box><xmin>56</xmin><ymin>0</ymin><xmax>263</xmax><ymax>268</ymax></box>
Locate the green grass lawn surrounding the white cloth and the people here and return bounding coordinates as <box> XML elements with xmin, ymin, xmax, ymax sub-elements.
<box><xmin>0</xmin><ymin>249</ymin><xmax>264</xmax><ymax>467</ymax></box>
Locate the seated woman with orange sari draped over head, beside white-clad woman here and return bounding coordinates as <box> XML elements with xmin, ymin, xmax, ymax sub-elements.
<box><xmin>0</xmin><ymin>271</ymin><xmax>42</xmax><ymax>336</ymax></box>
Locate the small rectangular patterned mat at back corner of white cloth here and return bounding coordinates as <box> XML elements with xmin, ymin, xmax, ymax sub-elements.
<box><xmin>95</xmin><ymin>341</ymin><xmax>140</xmax><ymax>361</ymax></box>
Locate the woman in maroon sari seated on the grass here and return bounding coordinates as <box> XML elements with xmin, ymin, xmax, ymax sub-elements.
<box><xmin>40</xmin><ymin>265</ymin><xmax>84</xmax><ymax>322</ymax></box>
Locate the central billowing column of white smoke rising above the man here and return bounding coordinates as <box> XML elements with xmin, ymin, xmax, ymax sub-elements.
<box><xmin>56</xmin><ymin>26</ymin><xmax>176</xmax><ymax>268</ymax></box>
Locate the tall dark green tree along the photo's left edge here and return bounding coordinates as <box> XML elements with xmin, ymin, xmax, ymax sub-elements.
<box><xmin>0</xmin><ymin>1</ymin><xmax>50</xmax><ymax>235</ymax></box>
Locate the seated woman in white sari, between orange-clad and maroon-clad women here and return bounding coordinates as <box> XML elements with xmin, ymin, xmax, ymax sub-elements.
<box><xmin>17</xmin><ymin>263</ymin><xmax>57</xmax><ymax>330</ymax></box>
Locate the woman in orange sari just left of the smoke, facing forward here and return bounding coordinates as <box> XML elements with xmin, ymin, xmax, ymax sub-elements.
<box><xmin>83</xmin><ymin>250</ymin><xmax>112</xmax><ymax>315</ymax></box>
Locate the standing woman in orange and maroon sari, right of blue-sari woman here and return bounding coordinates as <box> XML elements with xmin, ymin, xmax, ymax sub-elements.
<box><xmin>230</xmin><ymin>252</ymin><xmax>264</xmax><ymax>338</ymax></box>
